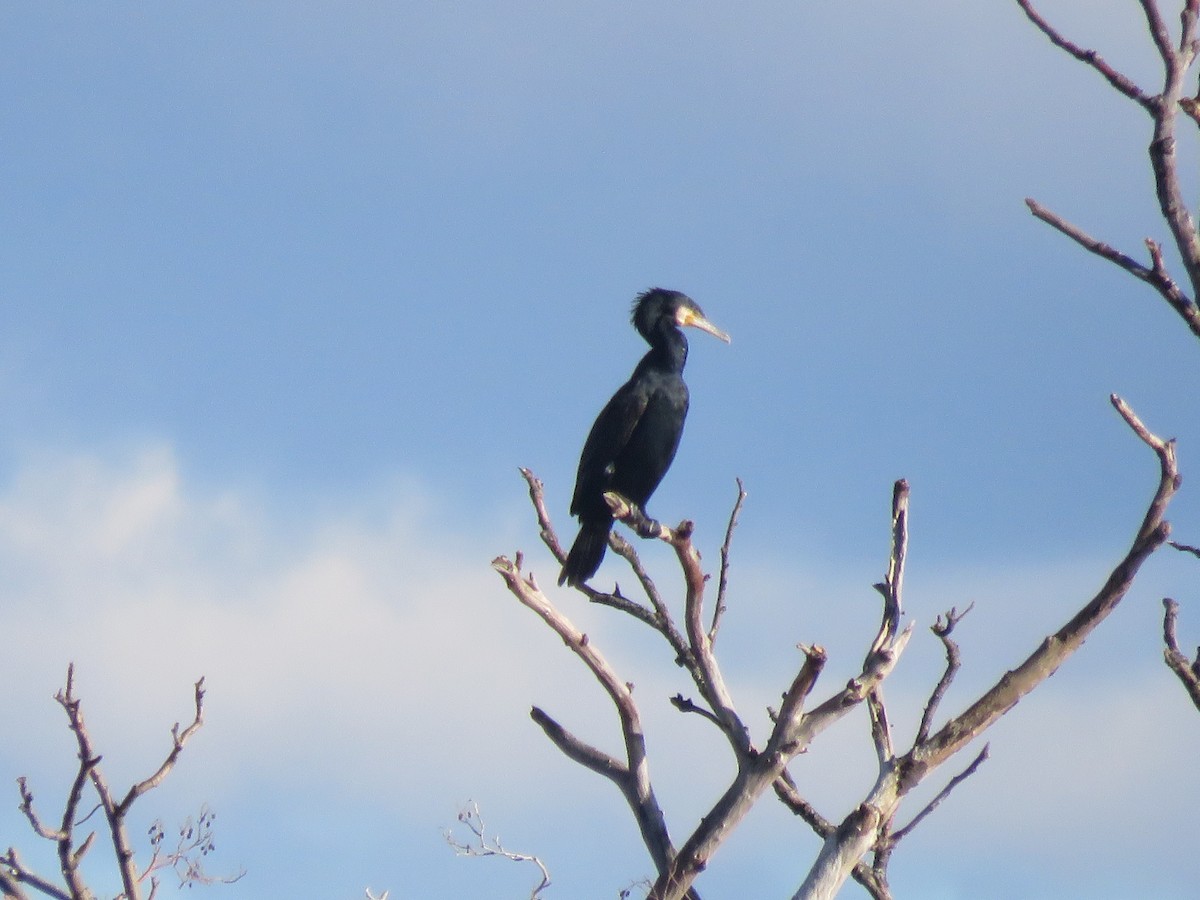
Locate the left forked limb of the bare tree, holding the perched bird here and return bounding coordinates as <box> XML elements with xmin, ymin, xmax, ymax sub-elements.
<box><xmin>493</xmin><ymin>469</ymin><xmax>912</xmax><ymax>900</ymax></box>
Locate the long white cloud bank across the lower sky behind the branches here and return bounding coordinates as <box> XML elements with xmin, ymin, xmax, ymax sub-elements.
<box><xmin>0</xmin><ymin>445</ymin><xmax>1200</xmax><ymax>895</ymax></box>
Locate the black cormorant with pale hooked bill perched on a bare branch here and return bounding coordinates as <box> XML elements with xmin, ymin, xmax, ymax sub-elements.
<box><xmin>558</xmin><ymin>288</ymin><xmax>730</xmax><ymax>584</ymax></box>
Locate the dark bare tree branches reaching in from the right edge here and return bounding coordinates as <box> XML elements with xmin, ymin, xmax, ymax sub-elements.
<box><xmin>1016</xmin><ymin>0</ymin><xmax>1200</xmax><ymax>708</ymax></box>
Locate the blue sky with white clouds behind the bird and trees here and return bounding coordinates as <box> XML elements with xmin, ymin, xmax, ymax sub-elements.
<box><xmin>0</xmin><ymin>0</ymin><xmax>1200</xmax><ymax>900</ymax></box>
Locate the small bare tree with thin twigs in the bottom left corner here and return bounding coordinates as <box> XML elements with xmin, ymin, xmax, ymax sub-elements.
<box><xmin>0</xmin><ymin>664</ymin><xmax>241</xmax><ymax>900</ymax></box>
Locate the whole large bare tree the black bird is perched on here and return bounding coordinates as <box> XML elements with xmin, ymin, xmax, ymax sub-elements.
<box><xmin>492</xmin><ymin>396</ymin><xmax>1180</xmax><ymax>900</ymax></box>
